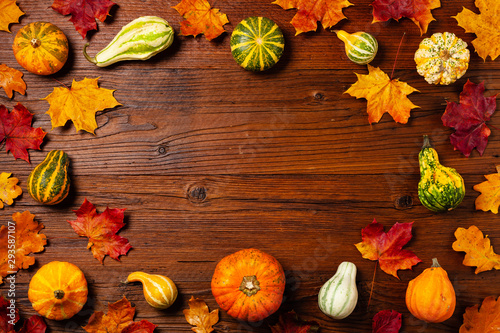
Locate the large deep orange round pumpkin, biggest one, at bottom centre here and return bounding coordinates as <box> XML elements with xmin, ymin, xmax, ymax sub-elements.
<box><xmin>212</xmin><ymin>249</ymin><xmax>285</xmax><ymax>322</ymax></box>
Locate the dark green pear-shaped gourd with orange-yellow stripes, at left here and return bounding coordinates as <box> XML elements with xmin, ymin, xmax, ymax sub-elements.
<box><xmin>28</xmin><ymin>150</ymin><xmax>70</xmax><ymax>205</ymax></box>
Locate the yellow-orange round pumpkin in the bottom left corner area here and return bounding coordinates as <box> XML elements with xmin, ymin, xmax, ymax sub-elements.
<box><xmin>28</xmin><ymin>261</ymin><xmax>88</xmax><ymax>320</ymax></box>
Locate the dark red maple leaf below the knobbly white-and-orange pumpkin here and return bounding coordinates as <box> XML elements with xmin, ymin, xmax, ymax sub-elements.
<box><xmin>441</xmin><ymin>80</ymin><xmax>497</xmax><ymax>157</ymax></box>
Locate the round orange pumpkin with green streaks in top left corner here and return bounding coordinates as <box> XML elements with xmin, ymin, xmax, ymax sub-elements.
<box><xmin>12</xmin><ymin>22</ymin><xmax>68</xmax><ymax>75</ymax></box>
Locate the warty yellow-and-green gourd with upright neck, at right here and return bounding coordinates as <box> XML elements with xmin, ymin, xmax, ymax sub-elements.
<box><xmin>418</xmin><ymin>135</ymin><xmax>465</xmax><ymax>212</ymax></box>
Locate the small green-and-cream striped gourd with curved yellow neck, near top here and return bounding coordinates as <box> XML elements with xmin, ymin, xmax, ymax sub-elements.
<box><xmin>334</xmin><ymin>30</ymin><xmax>378</xmax><ymax>65</ymax></box>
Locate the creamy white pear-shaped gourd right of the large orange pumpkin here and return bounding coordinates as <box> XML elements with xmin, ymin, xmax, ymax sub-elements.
<box><xmin>318</xmin><ymin>261</ymin><xmax>358</xmax><ymax>319</ymax></box>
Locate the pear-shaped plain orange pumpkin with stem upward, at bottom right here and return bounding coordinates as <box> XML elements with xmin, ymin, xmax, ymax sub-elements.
<box><xmin>406</xmin><ymin>258</ymin><xmax>456</xmax><ymax>323</ymax></box>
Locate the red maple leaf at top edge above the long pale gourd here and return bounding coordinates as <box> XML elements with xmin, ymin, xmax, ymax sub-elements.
<box><xmin>51</xmin><ymin>0</ymin><xmax>115</xmax><ymax>38</ymax></box>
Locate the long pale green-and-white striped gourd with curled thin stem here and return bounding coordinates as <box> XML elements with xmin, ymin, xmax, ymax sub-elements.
<box><xmin>83</xmin><ymin>16</ymin><xmax>174</xmax><ymax>67</ymax></box>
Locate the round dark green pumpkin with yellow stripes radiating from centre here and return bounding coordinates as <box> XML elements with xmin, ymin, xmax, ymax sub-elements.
<box><xmin>230</xmin><ymin>16</ymin><xmax>285</xmax><ymax>72</ymax></box>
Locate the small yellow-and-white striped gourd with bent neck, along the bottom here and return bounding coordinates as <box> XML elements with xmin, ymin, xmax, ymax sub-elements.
<box><xmin>125</xmin><ymin>272</ymin><xmax>177</xmax><ymax>309</ymax></box>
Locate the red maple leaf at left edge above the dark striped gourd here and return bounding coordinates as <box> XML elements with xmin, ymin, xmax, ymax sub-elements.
<box><xmin>0</xmin><ymin>103</ymin><xmax>47</xmax><ymax>163</ymax></box>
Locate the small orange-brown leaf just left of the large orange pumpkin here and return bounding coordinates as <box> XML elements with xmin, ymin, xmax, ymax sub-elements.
<box><xmin>182</xmin><ymin>296</ymin><xmax>219</xmax><ymax>333</ymax></box>
